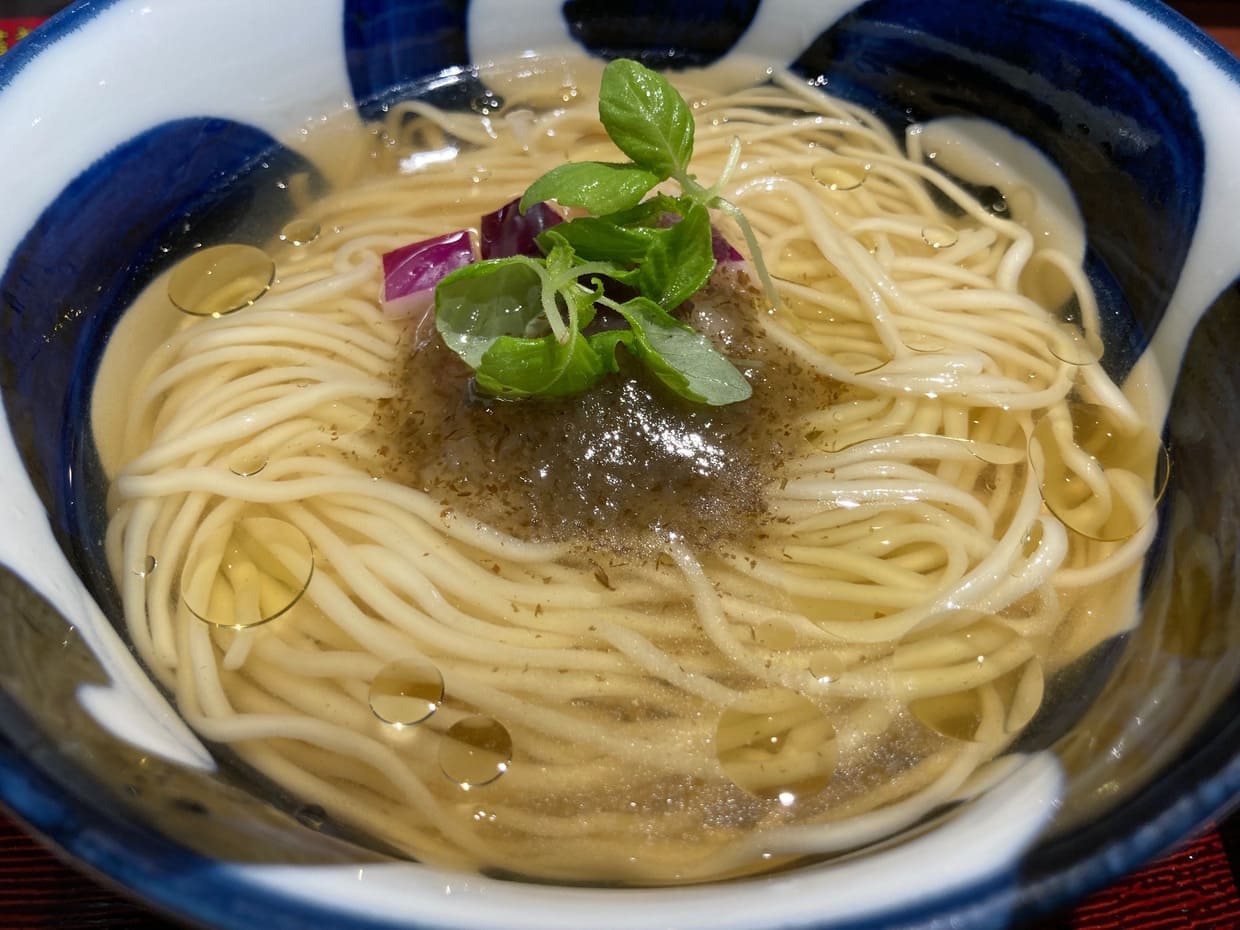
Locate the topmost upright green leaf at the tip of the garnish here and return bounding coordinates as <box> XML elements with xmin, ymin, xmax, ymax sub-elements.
<box><xmin>599</xmin><ymin>58</ymin><xmax>693</xmax><ymax>182</ymax></box>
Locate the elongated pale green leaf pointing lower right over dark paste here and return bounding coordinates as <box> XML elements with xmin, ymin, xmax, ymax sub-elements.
<box><xmin>616</xmin><ymin>298</ymin><xmax>753</xmax><ymax>407</ymax></box>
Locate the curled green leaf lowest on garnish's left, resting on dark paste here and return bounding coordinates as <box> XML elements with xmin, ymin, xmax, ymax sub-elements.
<box><xmin>474</xmin><ymin>332</ymin><xmax>605</xmax><ymax>397</ymax></box>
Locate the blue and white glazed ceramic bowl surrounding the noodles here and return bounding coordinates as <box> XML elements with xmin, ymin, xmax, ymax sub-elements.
<box><xmin>0</xmin><ymin>0</ymin><xmax>1240</xmax><ymax>930</ymax></box>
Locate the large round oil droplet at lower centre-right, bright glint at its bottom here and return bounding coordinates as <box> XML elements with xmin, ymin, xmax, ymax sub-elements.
<box><xmin>714</xmin><ymin>688</ymin><xmax>838</xmax><ymax>806</ymax></box>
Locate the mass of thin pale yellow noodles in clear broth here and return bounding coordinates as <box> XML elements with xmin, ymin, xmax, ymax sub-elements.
<box><xmin>99</xmin><ymin>62</ymin><xmax>1154</xmax><ymax>884</ymax></box>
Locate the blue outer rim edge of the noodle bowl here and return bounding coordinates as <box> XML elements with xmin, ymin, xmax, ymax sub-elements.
<box><xmin>0</xmin><ymin>0</ymin><xmax>1240</xmax><ymax>930</ymax></box>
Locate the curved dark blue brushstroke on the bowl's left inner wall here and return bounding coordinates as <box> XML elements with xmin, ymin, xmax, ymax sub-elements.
<box><xmin>0</xmin><ymin>118</ymin><xmax>320</xmax><ymax>582</ymax></box>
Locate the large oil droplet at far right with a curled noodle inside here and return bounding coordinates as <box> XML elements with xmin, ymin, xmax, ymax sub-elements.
<box><xmin>1029</xmin><ymin>401</ymin><xmax>1171</xmax><ymax>542</ymax></box>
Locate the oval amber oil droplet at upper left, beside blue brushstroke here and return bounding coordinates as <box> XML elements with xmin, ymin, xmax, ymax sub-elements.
<box><xmin>167</xmin><ymin>243</ymin><xmax>275</xmax><ymax>316</ymax></box>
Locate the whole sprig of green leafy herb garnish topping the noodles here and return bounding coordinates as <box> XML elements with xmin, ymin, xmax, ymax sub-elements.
<box><xmin>435</xmin><ymin>58</ymin><xmax>770</xmax><ymax>405</ymax></box>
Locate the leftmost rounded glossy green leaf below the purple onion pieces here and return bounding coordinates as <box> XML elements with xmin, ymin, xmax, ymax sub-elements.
<box><xmin>435</xmin><ymin>255</ymin><xmax>543</xmax><ymax>371</ymax></box>
